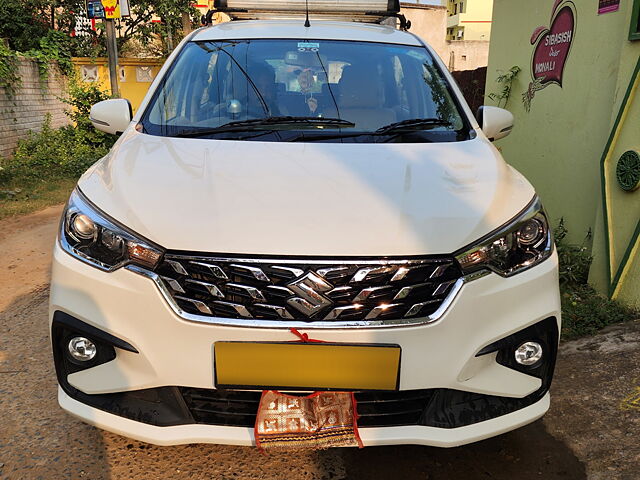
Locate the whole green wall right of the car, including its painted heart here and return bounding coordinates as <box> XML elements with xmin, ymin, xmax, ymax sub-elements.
<box><xmin>485</xmin><ymin>0</ymin><xmax>640</xmax><ymax>305</ymax></box>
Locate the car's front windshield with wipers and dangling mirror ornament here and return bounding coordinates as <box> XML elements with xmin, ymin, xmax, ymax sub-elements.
<box><xmin>141</xmin><ymin>39</ymin><xmax>470</xmax><ymax>142</ymax></box>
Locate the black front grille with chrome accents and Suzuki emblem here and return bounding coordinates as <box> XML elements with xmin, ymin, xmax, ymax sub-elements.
<box><xmin>156</xmin><ymin>254</ymin><xmax>462</xmax><ymax>324</ymax></box>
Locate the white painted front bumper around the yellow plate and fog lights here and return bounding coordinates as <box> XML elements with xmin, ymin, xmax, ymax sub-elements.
<box><xmin>50</xmin><ymin>244</ymin><xmax>560</xmax><ymax>446</ymax></box>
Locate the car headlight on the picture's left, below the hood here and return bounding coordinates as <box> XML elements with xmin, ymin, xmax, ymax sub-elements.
<box><xmin>60</xmin><ymin>189</ymin><xmax>162</xmax><ymax>271</ymax></box>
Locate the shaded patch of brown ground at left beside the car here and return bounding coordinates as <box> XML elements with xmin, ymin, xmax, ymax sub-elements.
<box><xmin>0</xmin><ymin>287</ymin><xmax>109</xmax><ymax>480</ymax></box>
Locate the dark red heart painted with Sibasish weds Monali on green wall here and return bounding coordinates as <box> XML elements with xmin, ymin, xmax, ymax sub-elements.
<box><xmin>523</xmin><ymin>0</ymin><xmax>576</xmax><ymax>111</ymax></box>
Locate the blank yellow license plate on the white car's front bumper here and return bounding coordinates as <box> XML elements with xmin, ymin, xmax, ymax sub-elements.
<box><xmin>214</xmin><ymin>342</ymin><xmax>400</xmax><ymax>390</ymax></box>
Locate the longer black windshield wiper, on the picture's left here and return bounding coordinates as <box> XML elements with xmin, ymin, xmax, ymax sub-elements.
<box><xmin>174</xmin><ymin>116</ymin><xmax>355</xmax><ymax>137</ymax></box>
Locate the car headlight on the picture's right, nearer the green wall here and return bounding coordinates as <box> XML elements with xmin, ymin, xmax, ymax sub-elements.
<box><xmin>455</xmin><ymin>197</ymin><xmax>553</xmax><ymax>277</ymax></box>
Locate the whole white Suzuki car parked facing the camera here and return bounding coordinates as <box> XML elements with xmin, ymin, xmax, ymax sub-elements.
<box><xmin>50</xmin><ymin>0</ymin><xmax>560</xmax><ymax>447</ymax></box>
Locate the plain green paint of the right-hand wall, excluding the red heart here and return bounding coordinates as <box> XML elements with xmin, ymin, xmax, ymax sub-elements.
<box><xmin>486</xmin><ymin>0</ymin><xmax>640</xmax><ymax>303</ymax></box>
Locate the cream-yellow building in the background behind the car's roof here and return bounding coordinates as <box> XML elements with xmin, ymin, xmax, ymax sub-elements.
<box><xmin>447</xmin><ymin>0</ymin><xmax>493</xmax><ymax>42</ymax></box>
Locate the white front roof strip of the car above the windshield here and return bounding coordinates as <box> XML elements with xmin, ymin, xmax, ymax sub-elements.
<box><xmin>191</xmin><ymin>18</ymin><xmax>421</xmax><ymax>46</ymax></box>
